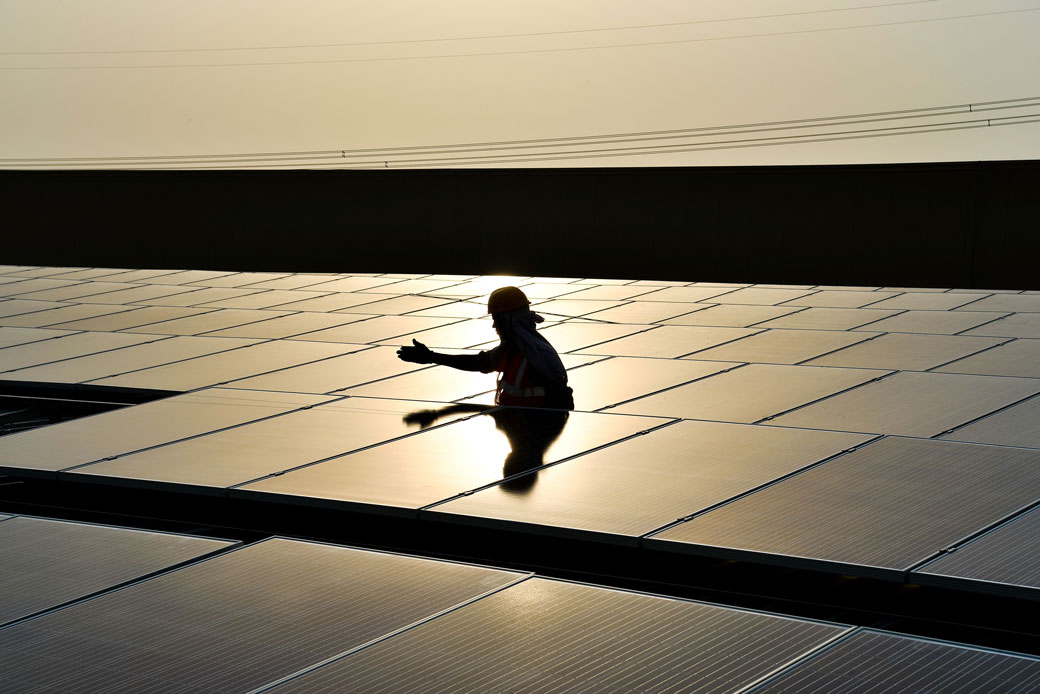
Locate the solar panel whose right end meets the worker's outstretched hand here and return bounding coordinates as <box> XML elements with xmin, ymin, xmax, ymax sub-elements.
<box><xmin>233</xmin><ymin>344</ymin><xmax>418</xmax><ymax>395</ymax></box>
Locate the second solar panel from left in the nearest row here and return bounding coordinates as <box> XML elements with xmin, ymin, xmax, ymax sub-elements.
<box><xmin>0</xmin><ymin>539</ymin><xmax>522</xmax><ymax>692</ymax></box>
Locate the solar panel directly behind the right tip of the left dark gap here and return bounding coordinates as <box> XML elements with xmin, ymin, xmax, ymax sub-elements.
<box><xmin>92</xmin><ymin>340</ymin><xmax>358</xmax><ymax>391</ymax></box>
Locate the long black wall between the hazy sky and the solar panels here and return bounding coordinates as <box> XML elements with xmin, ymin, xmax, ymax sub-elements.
<box><xmin>0</xmin><ymin>161</ymin><xmax>1040</xmax><ymax>288</ymax></box>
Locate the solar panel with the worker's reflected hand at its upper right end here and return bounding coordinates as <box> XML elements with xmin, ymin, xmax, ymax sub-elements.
<box><xmin>62</xmin><ymin>397</ymin><xmax>472</xmax><ymax>495</ymax></box>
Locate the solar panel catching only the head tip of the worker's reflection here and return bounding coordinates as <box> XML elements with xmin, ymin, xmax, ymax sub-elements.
<box><xmin>423</xmin><ymin>420</ymin><xmax>870</xmax><ymax>544</ymax></box>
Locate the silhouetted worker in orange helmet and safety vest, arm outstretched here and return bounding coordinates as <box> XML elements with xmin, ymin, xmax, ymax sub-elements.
<box><xmin>397</xmin><ymin>287</ymin><xmax>574</xmax><ymax>410</ymax></box>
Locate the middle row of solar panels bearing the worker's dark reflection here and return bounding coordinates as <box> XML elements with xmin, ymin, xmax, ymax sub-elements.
<box><xmin>0</xmin><ymin>389</ymin><xmax>1040</xmax><ymax>597</ymax></box>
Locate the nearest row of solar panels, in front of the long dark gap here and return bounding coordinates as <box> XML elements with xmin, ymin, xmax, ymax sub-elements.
<box><xmin>0</xmin><ymin>516</ymin><xmax>1040</xmax><ymax>694</ymax></box>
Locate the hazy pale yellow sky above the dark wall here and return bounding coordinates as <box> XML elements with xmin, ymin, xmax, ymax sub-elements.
<box><xmin>0</xmin><ymin>0</ymin><xmax>1040</xmax><ymax>168</ymax></box>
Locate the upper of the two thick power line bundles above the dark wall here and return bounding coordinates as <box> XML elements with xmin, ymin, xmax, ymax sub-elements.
<box><xmin>0</xmin><ymin>97</ymin><xmax>1040</xmax><ymax>165</ymax></box>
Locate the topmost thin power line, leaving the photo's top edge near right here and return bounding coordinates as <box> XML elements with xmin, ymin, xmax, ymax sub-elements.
<box><xmin>0</xmin><ymin>0</ymin><xmax>940</xmax><ymax>55</ymax></box>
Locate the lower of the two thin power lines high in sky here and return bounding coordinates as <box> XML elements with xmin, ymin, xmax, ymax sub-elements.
<box><xmin>0</xmin><ymin>7</ymin><xmax>1040</xmax><ymax>70</ymax></box>
